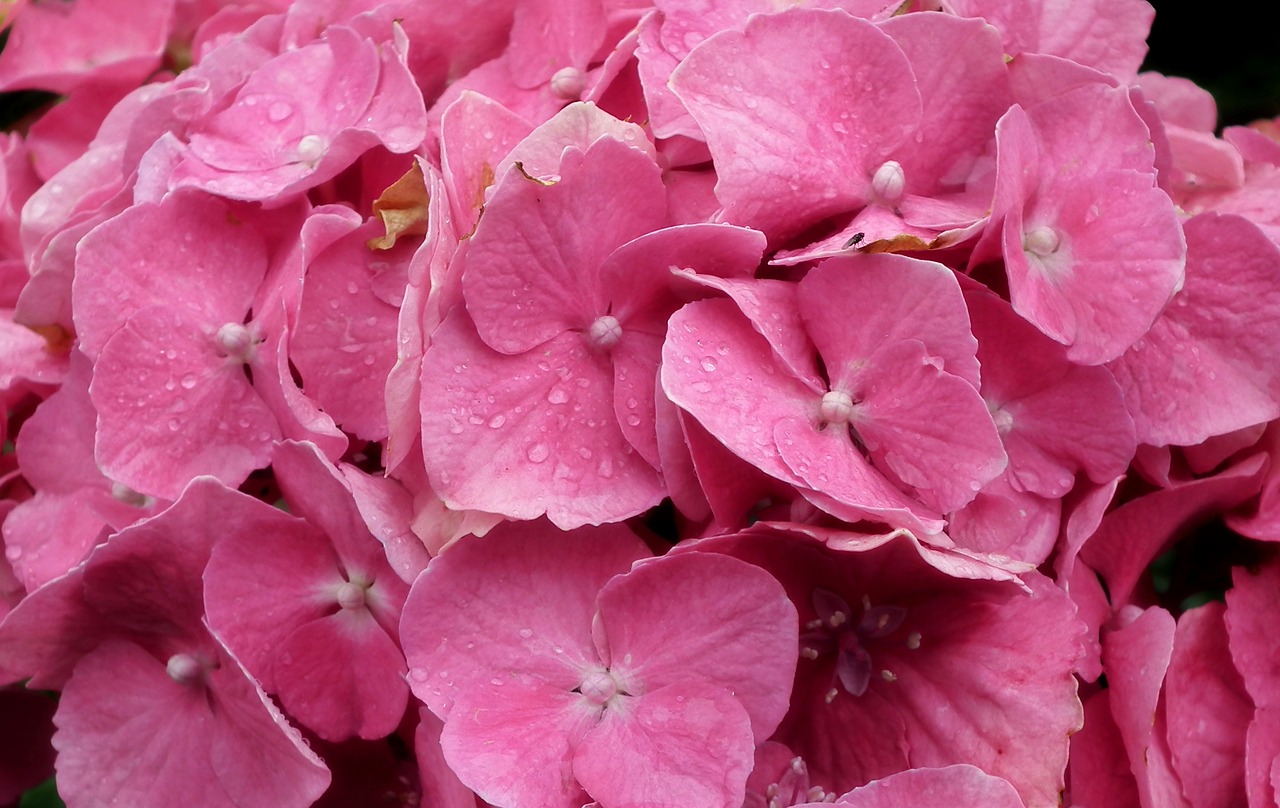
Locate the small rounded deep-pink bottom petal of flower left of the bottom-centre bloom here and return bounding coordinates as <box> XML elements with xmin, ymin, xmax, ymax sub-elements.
<box><xmin>271</xmin><ymin>610</ymin><xmax>408</xmax><ymax>740</ymax></box>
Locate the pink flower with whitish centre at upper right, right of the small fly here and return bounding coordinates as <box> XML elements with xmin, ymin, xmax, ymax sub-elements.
<box><xmin>993</xmin><ymin>86</ymin><xmax>1185</xmax><ymax>365</ymax></box>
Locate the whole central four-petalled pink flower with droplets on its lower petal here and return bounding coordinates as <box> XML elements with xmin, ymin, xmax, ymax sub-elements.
<box><xmin>421</xmin><ymin>131</ymin><xmax>763</xmax><ymax>528</ymax></box>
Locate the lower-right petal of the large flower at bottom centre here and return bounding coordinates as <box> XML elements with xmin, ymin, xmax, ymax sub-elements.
<box><xmin>573</xmin><ymin>683</ymin><xmax>755</xmax><ymax>808</ymax></box>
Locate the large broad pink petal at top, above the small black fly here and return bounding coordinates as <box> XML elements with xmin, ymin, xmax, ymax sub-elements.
<box><xmin>671</xmin><ymin>9</ymin><xmax>920</xmax><ymax>242</ymax></box>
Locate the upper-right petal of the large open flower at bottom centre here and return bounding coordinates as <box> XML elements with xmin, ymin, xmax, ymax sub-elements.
<box><xmin>599</xmin><ymin>553</ymin><xmax>799</xmax><ymax>740</ymax></box>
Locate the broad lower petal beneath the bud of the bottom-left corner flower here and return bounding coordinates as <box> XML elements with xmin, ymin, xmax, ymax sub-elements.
<box><xmin>54</xmin><ymin>642</ymin><xmax>329</xmax><ymax>808</ymax></box>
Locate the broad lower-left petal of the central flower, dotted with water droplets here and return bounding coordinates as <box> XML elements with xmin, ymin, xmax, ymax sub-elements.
<box><xmin>421</xmin><ymin>312</ymin><xmax>666</xmax><ymax>529</ymax></box>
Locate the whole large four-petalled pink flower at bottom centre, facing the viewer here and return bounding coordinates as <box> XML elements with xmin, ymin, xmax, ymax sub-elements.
<box><xmin>401</xmin><ymin>524</ymin><xmax>797</xmax><ymax>808</ymax></box>
